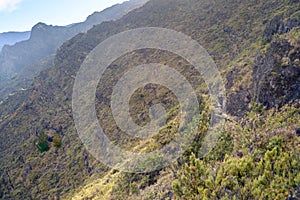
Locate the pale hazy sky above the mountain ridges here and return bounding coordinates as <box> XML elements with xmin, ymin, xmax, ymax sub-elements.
<box><xmin>0</xmin><ymin>0</ymin><xmax>126</xmax><ymax>33</ymax></box>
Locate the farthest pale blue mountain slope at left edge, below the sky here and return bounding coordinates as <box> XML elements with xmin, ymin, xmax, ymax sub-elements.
<box><xmin>0</xmin><ymin>31</ymin><xmax>30</xmax><ymax>51</ymax></box>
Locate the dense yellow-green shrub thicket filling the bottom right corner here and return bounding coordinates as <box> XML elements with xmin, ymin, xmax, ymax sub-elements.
<box><xmin>173</xmin><ymin>106</ymin><xmax>300</xmax><ymax>200</ymax></box>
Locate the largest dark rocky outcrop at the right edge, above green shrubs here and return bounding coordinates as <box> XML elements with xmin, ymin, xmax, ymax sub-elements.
<box><xmin>253</xmin><ymin>40</ymin><xmax>300</xmax><ymax>108</ymax></box>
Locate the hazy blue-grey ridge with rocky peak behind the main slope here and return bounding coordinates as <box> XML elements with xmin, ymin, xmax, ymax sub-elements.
<box><xmin>0</xmin><ymin>0</ymin><xmax>146</xmax><ymax>100</ymax></box>
